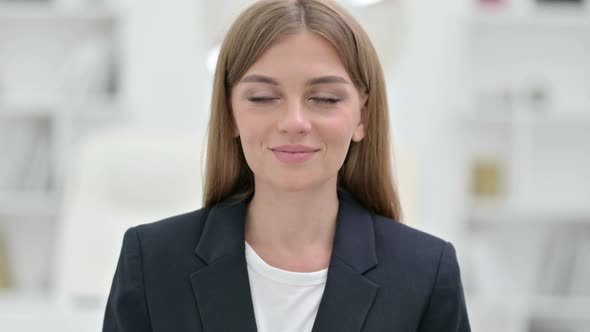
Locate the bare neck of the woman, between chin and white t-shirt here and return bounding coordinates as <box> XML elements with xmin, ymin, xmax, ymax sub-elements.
<box><xmin>245</xmin><ymin>179</ymin><xmax>338</xmax><ymax>253</ymax></box>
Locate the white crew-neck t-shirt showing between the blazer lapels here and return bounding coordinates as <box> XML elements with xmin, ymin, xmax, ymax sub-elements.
<box><xmin>246</xmin><ymin>242</ymin><xmax>328</xmax><ymax>332</ymax></box>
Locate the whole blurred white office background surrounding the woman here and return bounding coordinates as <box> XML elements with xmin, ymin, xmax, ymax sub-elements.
<box><xmin>0</xmin><ymin>0</ymin><xmax>590</xmax><ymax>332</ymax></box>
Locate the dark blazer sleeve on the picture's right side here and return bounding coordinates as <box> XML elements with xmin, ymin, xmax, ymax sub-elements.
<box><xmin>418</xmin><ymin>242</ymin><xmax>471</xmax><ymax>332</ymax></box>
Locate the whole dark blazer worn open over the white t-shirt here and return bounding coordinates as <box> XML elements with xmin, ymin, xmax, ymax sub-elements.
<box><xmin>103</xmin><ymin>192</ymin><xmax>470</xmax><ymax>332</ymax></box>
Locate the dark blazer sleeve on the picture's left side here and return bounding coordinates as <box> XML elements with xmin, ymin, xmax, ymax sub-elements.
<box><xmin>102</xmin><ymin>227</ymin><xmax>152</xmax><ymax>332</ymax></box>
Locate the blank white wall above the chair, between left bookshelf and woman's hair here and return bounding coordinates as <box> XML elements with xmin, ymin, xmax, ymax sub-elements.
<box><xmin>115</xmin><ymin>0</ymin><xmax>211</xmax><ymax>130</ymax></box>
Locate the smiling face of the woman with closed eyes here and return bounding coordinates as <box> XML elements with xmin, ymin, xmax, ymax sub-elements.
<box><xmin>231</xmin><ymin>32</ymin><xmax>366</xmax><ymax>191</ymax></box>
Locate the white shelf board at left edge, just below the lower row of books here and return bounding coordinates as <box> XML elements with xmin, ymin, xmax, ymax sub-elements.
<box><xmin>0</xmin><ymin>191</ymin><xmax>58</xmax><ymax>217</ymax></box>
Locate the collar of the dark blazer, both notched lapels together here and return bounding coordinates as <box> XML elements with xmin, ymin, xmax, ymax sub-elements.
<box><xmin>190</xmin><ymin>190</ymin><xmax>379</xmax><ymax>332</ymax></box>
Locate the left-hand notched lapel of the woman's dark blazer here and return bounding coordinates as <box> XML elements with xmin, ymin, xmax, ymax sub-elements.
<box><xmin>190</xmin><ymin>203</ymin><xmax>256</xmax><ymax>332</ymax></box>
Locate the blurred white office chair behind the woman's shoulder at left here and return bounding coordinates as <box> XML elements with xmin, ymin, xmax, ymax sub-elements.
<box><xmin>55</xmin><ymin>127</ymin><xmax>205</xmax><ymax>306</ymax></box>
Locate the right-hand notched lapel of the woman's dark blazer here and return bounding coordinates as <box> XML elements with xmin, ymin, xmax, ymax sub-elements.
<box><xmin>312</xmin><ymin>191</ymin><xmax>379</xmax><ymax>332</ymax></box>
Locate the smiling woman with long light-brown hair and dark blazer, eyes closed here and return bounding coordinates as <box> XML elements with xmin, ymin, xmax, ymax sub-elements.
<box><xmin>103</xmin><ymin>0</ymin><xmax>470</xmax><ymax>332</ymax></box>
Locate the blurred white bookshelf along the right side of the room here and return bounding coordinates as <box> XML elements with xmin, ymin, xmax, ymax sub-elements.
<box><xmin>458</xmin><ymin>0</ymin><xmax>590</xmax><ymax>332</ymax></box>
